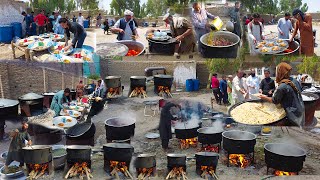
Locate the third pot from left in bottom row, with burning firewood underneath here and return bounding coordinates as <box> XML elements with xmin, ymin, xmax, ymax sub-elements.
<box><xmin>103</xmin><ymin>143</ymin><xmax>134</xmax><ymax>179</ymax></box>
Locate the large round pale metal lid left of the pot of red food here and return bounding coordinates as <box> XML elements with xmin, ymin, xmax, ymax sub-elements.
<box><xmin>96</xmin><ymin>43</ymin><xmax>129</xmax><ymax>58</ymax></box>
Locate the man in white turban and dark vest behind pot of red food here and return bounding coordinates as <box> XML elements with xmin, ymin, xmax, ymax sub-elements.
<box><xmin>111</xmin><ymin>10</ymin><xmax>138</xmax><ymax>41</ymax></box>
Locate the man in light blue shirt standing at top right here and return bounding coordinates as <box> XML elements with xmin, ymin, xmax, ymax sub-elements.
<box><xmin>278</xmin><ymin>13</ymin><xmax>293</xmax><ymax>39</ymax></box>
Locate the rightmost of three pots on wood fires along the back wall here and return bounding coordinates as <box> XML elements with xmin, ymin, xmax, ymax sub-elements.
<box><xmin>154</xmin><ymin>75</ymin><xmax>173</xmax><ymax>97</ymax></box>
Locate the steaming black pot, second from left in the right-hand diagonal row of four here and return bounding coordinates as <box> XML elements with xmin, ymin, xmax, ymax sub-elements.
<box><xmin>198</xmin><ymin>127</ymin><xmax>223</xmax><ymax>144</ymax></box>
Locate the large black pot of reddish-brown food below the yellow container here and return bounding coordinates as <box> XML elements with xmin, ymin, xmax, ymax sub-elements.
<box><xmin>200</xmin><ymin>31</ymin><xmax>240</xmax><ymax>58</ymax></box>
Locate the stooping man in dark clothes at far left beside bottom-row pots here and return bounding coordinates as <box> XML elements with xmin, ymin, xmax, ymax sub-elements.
<box><xmin>5</xmin><ymin>122</ymin><xmax>32</xmax><ymax>172</ymax></box>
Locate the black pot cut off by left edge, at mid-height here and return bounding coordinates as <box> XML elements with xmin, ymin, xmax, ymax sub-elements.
<box><xmin>0</xmin><ymin>98</ymin><xmax>19</xmax><ymax>119</ymax></box>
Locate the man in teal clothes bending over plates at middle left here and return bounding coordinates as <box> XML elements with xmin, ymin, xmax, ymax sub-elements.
<box><xmin>50</xmin><ymin>88</ymin><xmax>70</xmax><ymax>116</ymax></box>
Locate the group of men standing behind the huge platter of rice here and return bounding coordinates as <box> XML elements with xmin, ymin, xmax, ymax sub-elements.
<box><xmin>211</xmin><ymin>69</ymin><xmax>275</xmax><ymax>105</ymax></box>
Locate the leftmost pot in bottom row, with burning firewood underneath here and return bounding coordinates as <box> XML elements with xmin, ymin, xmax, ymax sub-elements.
<box><xmin>23</xmin><ymin>145</ymin><xmax>53</xmax><ymax>179</ymax></box>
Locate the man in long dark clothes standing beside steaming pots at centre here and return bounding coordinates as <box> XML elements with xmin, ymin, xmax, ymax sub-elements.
<box><xmin>159</xmin><ymin>102</ymin><xmax>179</xmax><ymax>150</ymax></box>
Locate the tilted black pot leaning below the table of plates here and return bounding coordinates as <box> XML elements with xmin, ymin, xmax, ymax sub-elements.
<box><xmin>67</xmin><ymin>122</ymin><xmax>96</xmax><ymax>139</ymax></box>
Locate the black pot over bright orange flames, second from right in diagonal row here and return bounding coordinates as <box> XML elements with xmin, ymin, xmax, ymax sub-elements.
<box><xmin>222</xmin><ymin>130</ymin><xmax>257</xmax><ymax>168</ymax></box>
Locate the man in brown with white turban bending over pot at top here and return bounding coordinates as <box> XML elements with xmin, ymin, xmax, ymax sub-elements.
<box><xmin>163</xmin><ymin>13</ymin><xmax>196</xmax><ymax>56</ymax></box>
